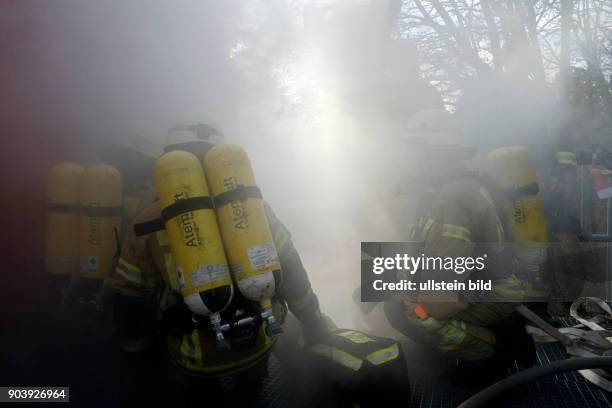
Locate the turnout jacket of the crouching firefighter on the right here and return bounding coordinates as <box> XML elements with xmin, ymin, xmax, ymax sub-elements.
<box><xmin>387</xmin><ymin>174</ymin><xmax>523</xmax><ymax>360</ymax></box>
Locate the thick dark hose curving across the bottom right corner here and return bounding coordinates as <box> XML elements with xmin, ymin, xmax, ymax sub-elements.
<box><xmin>458</xmin><ymin>357</ymin><xmax>612</xmax><ymax>408</ymax></box>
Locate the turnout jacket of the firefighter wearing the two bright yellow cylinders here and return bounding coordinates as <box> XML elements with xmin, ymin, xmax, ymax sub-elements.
<box><xmin>113</xmin><ymin>201</ymin><xmax>324</xmax><ymax>376</ymax></box>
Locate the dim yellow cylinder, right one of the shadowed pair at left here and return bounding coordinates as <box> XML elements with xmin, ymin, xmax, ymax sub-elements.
<box><xmin>79</xmin><ymin>164</ymin><xmax>123</xmax><ymax>279</ymax></box>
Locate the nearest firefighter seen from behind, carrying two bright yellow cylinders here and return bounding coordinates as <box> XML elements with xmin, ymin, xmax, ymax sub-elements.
<box><xmin>114</xmin><ymin>124</ymin><xmax>328</xmax><ymax>404</ymax></box>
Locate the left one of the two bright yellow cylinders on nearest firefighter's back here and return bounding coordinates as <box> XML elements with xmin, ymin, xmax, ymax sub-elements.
<box><xmin>155</xmin><ymin>151</ymin><xmax>233</xmax><ymax>316</ymax></box>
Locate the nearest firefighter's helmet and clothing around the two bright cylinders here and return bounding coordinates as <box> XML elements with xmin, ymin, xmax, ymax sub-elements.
<box><xmin>114</xmin><ymin>118</ymin><xmax>328</xmax><ymax>405</ymax></box>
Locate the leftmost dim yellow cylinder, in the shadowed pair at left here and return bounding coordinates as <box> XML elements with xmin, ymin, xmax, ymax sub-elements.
<box><xmin>45</xmin><ymin>162</ymin><xmax>83</xmax><ymax>275</ymax></box>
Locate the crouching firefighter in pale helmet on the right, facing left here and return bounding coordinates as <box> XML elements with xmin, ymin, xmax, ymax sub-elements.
<box><xmin>385</xmin><ymin>110</ymin><xmax>535</xmax><ymax>384</ymax></box>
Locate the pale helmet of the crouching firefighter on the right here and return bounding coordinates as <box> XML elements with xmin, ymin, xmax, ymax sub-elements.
<box><xmin>400</xmin><ymin>109</ymin><xmax>476</xmax><ymax>157</ymax></box>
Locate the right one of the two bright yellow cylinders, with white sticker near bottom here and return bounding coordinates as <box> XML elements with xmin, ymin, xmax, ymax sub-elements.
<box><xmin>204</xmin><ymin>144</ymin><xmax>280</xmax><ymax>312</ymax></box>
